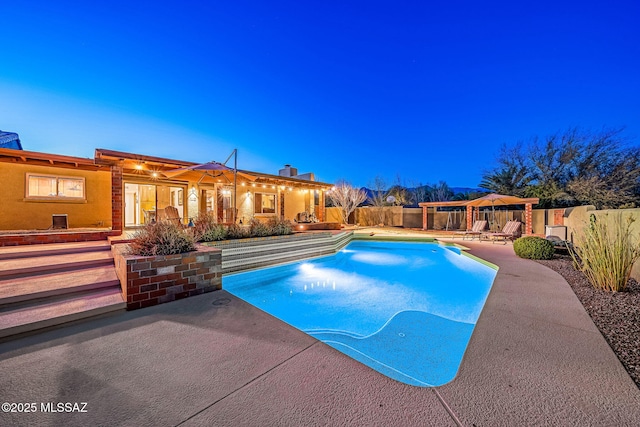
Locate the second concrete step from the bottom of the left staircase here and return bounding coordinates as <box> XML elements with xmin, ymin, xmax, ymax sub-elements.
<box><xmin>0</xmin><ymin>265</ymin><xmax>120</xmax><ymax>309</ymax></box>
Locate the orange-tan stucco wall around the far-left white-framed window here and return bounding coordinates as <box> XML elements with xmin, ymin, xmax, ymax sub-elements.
<box><xmin>0</xmin><ymin>163</ymin><xmax>111</xmax><ymax>230</ymax></box>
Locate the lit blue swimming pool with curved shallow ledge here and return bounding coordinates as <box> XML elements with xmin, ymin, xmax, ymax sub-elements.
<box><xmin>222</xmin><ymin>241</ymin><xmax>497</xmax><ymax>387</ymax></box>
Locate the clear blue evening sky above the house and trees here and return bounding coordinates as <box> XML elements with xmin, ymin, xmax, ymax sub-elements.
<box><xmin>0</xmin><ymin>0</ymin><xmax>640</xmax><ymax>187</ymax></box>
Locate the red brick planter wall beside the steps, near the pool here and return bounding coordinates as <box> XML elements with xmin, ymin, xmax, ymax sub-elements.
<box><xmin>112</xmin><ymin>244</ymin><xmax>222</xmax><ymax>310</ymax></box>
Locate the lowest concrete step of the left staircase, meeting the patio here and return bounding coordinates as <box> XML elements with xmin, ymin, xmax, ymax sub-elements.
<box><xmin>0</xmin><ymin>287</ymin><xmax>126</xmax><ymax>339</ymax></box>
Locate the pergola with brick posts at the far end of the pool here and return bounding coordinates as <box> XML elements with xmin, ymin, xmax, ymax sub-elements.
<box><xmin>418</xmin><ymin>193</ymin><xmax>540</xmax><ymax>234</ymax></box>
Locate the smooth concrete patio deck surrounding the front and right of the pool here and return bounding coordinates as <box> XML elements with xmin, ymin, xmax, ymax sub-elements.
<box><xmin>0</xmin><ymin>236</ymin><xmax>640</xmax><ymax>426</ymax></box>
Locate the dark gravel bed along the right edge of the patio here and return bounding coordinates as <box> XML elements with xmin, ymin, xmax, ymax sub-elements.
<box><xmin>538</xmin><ymin>255</ymin><xmax>640</xmax><ymax>388</ymax></box>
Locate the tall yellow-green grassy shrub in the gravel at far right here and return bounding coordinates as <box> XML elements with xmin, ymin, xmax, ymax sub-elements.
<box><xmin>570</xmin><ymin>214</ymin><xmax>640</xmax><ymax>292</ymax></box>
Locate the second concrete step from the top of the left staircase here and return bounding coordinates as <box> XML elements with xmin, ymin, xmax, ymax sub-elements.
<box><xmin>0</xmin><ymin>250</ymin><xmax>113</xmax><ymax>282</ymax></box>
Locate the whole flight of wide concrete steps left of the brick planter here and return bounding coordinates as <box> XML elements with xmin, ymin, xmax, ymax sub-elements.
<box><xmin>0</xmin><ymin>241</ymin><xmax>126</xmax><ymax>340</ymax></box>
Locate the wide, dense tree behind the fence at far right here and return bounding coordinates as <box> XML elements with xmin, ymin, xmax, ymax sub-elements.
<box><xmin>480</xmin><ymin>128</ymin><xmax>640</xmax><ymax>209</ymax></box>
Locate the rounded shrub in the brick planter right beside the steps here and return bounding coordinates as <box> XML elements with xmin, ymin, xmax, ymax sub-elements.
<box><xmin>129</xmin><ymin>221</ymin><xmax>196</xmax><ymax>256</ymax></box>
